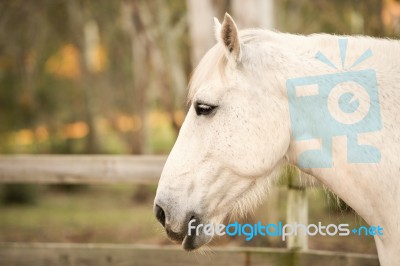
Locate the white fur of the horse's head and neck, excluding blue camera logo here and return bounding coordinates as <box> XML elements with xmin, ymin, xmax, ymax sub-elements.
<box><xmin>156</xmin><ymin>16</ymin><xmax>400</xmax><ymax>266</ymax></box>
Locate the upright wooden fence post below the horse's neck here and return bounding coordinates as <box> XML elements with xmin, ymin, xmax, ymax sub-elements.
<box><xmin>286</xmin><ymin>169</ymin><xmax>308</xmax><ymax>250</ymax></box>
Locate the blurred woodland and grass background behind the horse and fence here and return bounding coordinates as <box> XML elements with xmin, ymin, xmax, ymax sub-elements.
<box><xmin>0</xmin><ymin>0</ymin><xmax>400</xmax><ymax>253</ymax></box>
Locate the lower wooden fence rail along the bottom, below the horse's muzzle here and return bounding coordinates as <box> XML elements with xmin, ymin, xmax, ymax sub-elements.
<box><xmin>0</xmin><ymin>243</ymin><xmax>379</xmax><ymax>266</ymax></box>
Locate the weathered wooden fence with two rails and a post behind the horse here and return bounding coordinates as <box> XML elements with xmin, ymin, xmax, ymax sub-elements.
<box><xmin>0</xmin><ymin>155</ymin><xmax>379</xmax><ymax>266</ymax></box>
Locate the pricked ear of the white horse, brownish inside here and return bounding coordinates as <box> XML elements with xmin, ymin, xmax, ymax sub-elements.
<box><xmin>218</xmin><ymin>13</ymin><xmax>241</xmax><ymax>62</ymax></box>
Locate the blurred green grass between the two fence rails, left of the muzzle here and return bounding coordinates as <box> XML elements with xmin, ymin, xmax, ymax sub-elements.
<box><xmin>0</xmin><ymin>186</ymin><xmax>162</xmax><ymax>243</ymax></box>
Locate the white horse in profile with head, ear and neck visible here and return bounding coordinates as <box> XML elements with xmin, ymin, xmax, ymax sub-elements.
<box><xmin>154</xmin><ymin>14</ymin><xmax>400</xmax><ymax>265</ymax></box>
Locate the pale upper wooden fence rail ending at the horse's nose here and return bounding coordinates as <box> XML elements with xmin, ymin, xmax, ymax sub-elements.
<box><xmin>0</xmin><ymin>155</ymin><xmax>166</xmax><ymax>184</ymax></box>
